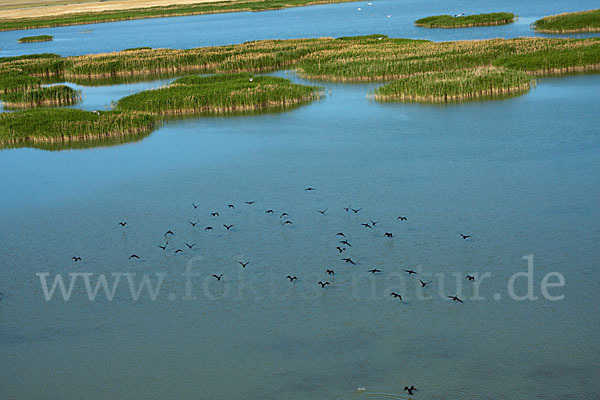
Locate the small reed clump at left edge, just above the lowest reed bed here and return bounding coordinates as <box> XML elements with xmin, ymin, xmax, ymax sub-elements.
<box><xmin>0</xmin><ymin>85</ymin><xmax>81</xmax><ymax>108</ymax></box>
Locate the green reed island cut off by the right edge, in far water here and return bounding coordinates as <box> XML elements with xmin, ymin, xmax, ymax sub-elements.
<box><xmin>533</xmin><ymin>9</ymin><xmax>600</xmax><ymax>33</ymax></box>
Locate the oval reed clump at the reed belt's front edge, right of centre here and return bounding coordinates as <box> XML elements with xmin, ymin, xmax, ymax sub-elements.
<box><xmin>374</xmin><ymin>67</ymin><xmax>531</xmax><ymax>102</ymax></box>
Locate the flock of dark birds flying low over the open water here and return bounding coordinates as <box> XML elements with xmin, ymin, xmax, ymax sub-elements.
<box><xmin>72</xmin><ymin>187</ymin><xmax>475</xmax><ymax>303</ymax></box>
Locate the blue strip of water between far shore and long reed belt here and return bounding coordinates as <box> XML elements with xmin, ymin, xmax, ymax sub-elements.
<box><xmin>0</xmin><ymin>0</ymin><xmax>598</xmax><ymax>57</ymax></box>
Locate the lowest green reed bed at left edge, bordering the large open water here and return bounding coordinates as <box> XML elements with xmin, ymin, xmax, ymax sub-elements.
<box><xmin>0</xmin><ymin>108</ymin><xmax>156</xmax><ymax>145</ymax></box>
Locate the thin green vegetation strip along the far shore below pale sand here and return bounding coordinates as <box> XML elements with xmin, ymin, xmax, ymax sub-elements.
<box><xmin>0</xmin><ymin>0</ymin><xmax>356</xmax><ymax>31</ymax></box>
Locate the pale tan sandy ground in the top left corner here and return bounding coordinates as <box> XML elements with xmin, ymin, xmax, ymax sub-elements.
<box><xmin>0</xmin><ymin>0</ymin><xmax>236</xmax><ymax>19</ymax></box>
